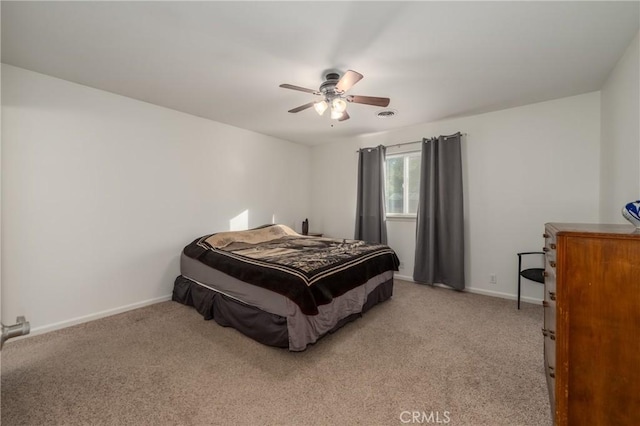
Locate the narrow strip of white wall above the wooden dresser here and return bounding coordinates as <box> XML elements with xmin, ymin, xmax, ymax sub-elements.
<box><xmin>600</xmin><ymin>33</ymin><xmax>640</xmax><ymax>223</ymax></box>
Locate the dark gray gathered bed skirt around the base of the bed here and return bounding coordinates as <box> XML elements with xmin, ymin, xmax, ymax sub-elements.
<box><xmin>172</xmin><ymin>275</ymin><xmax>393</xmax><ymax>351</ymax></box>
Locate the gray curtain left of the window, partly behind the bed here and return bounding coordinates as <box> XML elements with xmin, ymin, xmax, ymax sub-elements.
<box><xmin>355</xmin><ymin>145</ymin><xmax>387</xmax><ymax>244</ymax></box>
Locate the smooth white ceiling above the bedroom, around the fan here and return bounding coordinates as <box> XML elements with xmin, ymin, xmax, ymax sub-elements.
<box><xmin>1</xmin><ymin>1</ymin><xmax>640</xmax><ymax>145</ymax></box>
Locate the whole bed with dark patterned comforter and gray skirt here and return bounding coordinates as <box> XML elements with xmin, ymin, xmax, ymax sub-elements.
<box><xmin>173</xmin><ymin>225</ymin><xmax>399</xmax><ymax>351</ymax></box>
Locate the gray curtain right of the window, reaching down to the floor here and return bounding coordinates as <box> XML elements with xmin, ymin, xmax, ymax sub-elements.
<box><xmin>413</xmin><ymin>133</ymin><xmax>465</xmax><ymax>290</ymax></box>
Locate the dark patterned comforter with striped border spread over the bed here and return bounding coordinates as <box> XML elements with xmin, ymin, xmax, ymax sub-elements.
<box><xmin>184</xmin><ymin>231</ymin><xmax>400</xmax><ymax>315</ymax></box>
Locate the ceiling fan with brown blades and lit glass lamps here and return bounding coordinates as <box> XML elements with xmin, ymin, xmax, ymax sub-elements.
<box><xmin>280</xmin><ymin>70</ymin><xmax>390</xmax><ymax>121</ymax></box>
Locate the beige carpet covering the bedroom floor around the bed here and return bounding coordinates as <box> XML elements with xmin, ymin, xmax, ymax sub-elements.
<box><xmin>0</xmin><ymin>281</ymin><xmax>551</xmax><ymax>426</ymax></box>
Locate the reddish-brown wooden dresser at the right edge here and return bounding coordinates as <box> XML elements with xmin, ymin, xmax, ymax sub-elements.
<box><xmin>542</xmin><ymin>223</ymin><xmax>640</xmax><ymax>426</ymax></box>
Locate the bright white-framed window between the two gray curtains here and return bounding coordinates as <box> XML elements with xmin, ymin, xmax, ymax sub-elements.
<box><xmin>385</xmin><ymin>151</ymin><xmax>420</xmax><ymax>216</ymax></box>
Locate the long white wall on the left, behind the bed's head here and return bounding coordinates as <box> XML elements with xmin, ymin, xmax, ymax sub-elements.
<box><xmin>1</xmin><ymin>65</ymin><xmax>310</xmax><ymax>332</ymax></box>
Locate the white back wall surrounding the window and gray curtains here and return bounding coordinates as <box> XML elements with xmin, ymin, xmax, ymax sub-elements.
<box><xmin>310</xmin><ymin>92</ymin><xmax>600</xmax><ymax>300</ymax></box>
